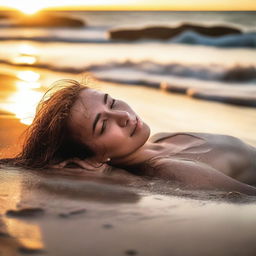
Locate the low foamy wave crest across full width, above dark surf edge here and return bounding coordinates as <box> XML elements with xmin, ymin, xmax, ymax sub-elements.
<box><xmin>0</xmin><ymin>60</ymin><xmax>256</xmax><ymax>85</ymax></box>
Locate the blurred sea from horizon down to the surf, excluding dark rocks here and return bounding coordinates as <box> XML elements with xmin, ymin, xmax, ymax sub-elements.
<box><xmin>0</xmin><ymin>11</ymin><xmax>256</xmax><ymax>123</ymax></box>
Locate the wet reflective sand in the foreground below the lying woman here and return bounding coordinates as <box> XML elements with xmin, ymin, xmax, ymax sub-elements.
<box><xmin>0</xmin><ymin>168</ymin><xmax>256</xmax><ymax>255</ymax></box>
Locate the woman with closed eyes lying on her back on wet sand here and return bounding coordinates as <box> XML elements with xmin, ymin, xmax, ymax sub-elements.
<box><xmin>2</xmin><ymin>80</ymin><xmax>256</xmax><ymax>195</ymax></box>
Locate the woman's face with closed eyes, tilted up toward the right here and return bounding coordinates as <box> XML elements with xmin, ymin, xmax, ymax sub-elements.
<box><xmin>69</xmin><ymin>89</ymin><xmax>150</xmax><ymax>160</ymax></box>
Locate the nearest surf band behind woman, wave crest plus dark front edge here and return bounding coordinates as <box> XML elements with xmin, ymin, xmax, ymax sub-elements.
<box><xmin>0</xmin><ymin>57</ymin><xmax>256</xmax><ymax>107</ymax></box>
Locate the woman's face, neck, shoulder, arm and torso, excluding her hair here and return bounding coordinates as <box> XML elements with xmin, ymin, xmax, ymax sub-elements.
<box><xmin>66</xmin><ymin>89</ymin><xmax>256</xmax><ymax>195</ymax></box>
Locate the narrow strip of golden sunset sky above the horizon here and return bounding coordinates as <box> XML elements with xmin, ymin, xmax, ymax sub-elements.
<box><xmin>0</xmin><ymin>0</ymin><xmax>256</xmax><ymax>13</ymax></box>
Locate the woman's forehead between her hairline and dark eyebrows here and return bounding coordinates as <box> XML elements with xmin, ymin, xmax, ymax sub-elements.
<box><xmin>69</xmin><ymin>89</ymin><xmax>105</xmax><ymax>137</ymax></box>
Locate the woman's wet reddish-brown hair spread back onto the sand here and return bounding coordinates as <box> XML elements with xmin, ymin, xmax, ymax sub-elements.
<box><xmin>0</xmin><ymin>79</ymin><xmax>94</xmax><ymax>168</ymax></box>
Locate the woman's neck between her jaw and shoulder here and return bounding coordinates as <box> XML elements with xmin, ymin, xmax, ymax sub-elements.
<box><xmin>111</xmin><ymin>142</ymin><xmax>162</xmax><ymax>166</ymax></box>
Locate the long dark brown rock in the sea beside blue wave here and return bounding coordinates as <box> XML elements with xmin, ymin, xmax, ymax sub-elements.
<box><xmin>109</xmin><ymin>24</ymin><xmax>242</xmax><ymax>41</ymax></box>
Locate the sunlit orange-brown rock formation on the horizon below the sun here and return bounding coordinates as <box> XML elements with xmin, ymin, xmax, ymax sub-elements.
<box><xmin>11</xmin><ymin>14</ymin><xmax>86</xmax><ymax>27</ymax></box>
